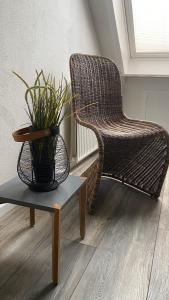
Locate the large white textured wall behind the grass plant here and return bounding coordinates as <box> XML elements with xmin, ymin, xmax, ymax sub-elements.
<box><xmin>0</xmin><ymin>0</ymin><xmax>100</xmax><ymax>183</ymax></box>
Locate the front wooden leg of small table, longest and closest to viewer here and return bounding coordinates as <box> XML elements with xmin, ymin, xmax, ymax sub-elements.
<box><xmin>52</xmin><ymin>205</ymin><xmax>60</xmax><ymax>284</ymax></box>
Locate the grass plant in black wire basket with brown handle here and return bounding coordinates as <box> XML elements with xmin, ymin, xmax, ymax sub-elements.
<box><xmin>13</xmin><ymin>71</ymin><xmax>72</xmax><ymax>191</ymax></box>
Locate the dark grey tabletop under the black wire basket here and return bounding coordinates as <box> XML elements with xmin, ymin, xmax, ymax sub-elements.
<box><xmin>0</xmin><ymin>175</ymin><xmax>85</xmax><ymax>211</ymax></box>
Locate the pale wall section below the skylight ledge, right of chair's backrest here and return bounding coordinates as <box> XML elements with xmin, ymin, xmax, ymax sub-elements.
<box><xmin>123</xmin><ymin>77</ymin><xmax>169</xmax><ymax>131</ymax></box>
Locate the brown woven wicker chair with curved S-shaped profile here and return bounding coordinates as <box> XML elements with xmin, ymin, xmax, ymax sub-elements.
<box><xmin>70</xmin><ymin>54</ymin><xmax>169</xmax><ymax>211</ymax></box>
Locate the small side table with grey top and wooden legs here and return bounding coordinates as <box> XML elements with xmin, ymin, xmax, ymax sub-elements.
<box><xmin>0</xmin><ymin>175</ymin><xmax>87</xmax><ymax>284</ymax></box>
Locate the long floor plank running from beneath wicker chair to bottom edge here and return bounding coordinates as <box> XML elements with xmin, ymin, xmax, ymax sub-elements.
<box><xmin>71</xmin><ymin>186</ymin><xmax>161</xmax><ymax>300</ymax></box>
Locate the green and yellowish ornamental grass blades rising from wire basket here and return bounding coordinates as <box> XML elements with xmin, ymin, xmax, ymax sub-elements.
<box><xmin>13</xmin><ymin>71</ymin><xmax>72</xmax><ymax>130</ymax></box>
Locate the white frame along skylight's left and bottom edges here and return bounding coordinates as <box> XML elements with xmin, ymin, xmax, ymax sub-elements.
<box><xmin>123</xmin><ymin>0</ymin><xmax>169</xmax><ymax>58</ymax></box>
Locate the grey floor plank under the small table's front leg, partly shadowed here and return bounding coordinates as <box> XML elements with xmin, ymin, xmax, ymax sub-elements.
<box><xmin>0</xmin><ymin>239</ymin><xmax>95</xmax><ymax>300</ymax></box>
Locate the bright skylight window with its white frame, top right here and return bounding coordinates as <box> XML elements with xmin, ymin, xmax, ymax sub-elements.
<box><xmin>124</xmin><ymin>0</ymin><xmax>169</xmax><ymax>56</ymax></box>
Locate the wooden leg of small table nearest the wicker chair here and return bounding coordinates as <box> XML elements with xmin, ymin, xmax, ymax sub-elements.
<box><xmin>79</xmin><ymin>184</ymin><xmax>87</xmax><ymax>239</ymax></box>
